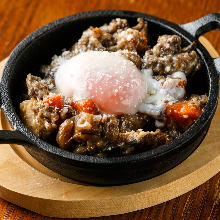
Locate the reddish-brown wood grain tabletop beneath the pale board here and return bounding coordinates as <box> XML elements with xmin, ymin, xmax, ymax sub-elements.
<box><xmin>0</xmin><ymin>0</ymin><xmax>220</xmax><ymax>220</ymax></box>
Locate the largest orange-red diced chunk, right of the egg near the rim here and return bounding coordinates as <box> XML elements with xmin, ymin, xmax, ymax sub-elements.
<box><xmin>164</xmin><ymin>101</ymin><xmax>202</xmax><ymax>131</ymax></box>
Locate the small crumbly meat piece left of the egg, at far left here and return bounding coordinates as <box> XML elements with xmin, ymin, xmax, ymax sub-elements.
<box><xmin>26</xmin><ymin>74</ymin><xmax>55</xmax><ymax>99</ymax></box>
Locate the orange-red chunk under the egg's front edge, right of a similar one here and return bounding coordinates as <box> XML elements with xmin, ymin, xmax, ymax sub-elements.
<box><xmin>71</xmin><ymin>99</ymin><xmax>98</xmax><ymax>115</ymax></box>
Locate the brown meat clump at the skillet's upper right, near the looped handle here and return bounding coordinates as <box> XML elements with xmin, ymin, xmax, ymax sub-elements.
<box><xmin>143</xmin><ymin>35</ymin><xmax>200</xmax><ymax>75</ymax></box>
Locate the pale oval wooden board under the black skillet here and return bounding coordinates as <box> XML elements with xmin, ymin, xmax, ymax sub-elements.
<box><xmin>0</xmin><ymin>38</ymin><xmax>220</xmax><ymax>218</ymax></box>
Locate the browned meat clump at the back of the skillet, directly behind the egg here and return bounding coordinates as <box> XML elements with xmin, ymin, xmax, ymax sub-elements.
<box><xmin>72</xmin><ymin>18</ymin><xmax>148</xmax><ymax>56</ymax></box>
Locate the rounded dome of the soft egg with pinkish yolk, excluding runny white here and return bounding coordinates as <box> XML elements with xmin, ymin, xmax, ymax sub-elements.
<box><xmin>55</xmin><ymin>51</ymin><xmax>146</xmax><ymax>114</ymax></box>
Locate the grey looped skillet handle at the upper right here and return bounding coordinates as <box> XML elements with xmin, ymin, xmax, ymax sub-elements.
<box><xmin>180</xmin><ymin>13</ymin><xmax>220</xmax><ymax>74</ymax></box>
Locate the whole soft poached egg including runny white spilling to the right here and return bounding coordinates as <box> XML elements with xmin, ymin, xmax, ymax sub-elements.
<box><xmin>55</xmin><ymin>51</ymin><xmax>186</xmax><ymax>118</ymax></box>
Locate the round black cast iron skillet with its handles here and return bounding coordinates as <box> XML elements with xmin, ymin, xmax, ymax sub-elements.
<box><xmin>0</xmin><ymin>10</ymin><xmax>220</xmax><ymax>185</ymax></box>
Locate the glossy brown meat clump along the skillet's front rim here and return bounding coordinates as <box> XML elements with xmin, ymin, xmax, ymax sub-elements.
<box><xmin>57</xmin><ymin>112</ymin><xmax>168</xmax><ymax>156</ymax></box>
